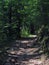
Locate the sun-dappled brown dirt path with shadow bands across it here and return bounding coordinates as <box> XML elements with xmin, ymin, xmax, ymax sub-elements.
<box><xmin>0</xmin><ymin>38</ymin><xmax>49</xmax><ymax>65</ymax></box>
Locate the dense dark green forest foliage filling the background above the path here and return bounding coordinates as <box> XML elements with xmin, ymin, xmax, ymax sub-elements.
<box><xmin>0</xmin><ymin>0</ymin><xmax>49</xmax><ymax>54</ymax></box>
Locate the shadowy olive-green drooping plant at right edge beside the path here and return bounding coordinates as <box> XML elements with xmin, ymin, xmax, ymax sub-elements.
<box><xmin>38</xmin><ymin>25</ymin><xmax>49</xmax><ymax>54</ymax></box>
